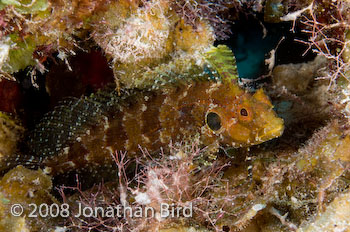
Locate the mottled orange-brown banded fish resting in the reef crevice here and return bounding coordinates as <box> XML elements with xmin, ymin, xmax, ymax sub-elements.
<box><xmin>0</xmin><ymin>45</ymin><xmax>284</xmax><ymax>175</ymax></box>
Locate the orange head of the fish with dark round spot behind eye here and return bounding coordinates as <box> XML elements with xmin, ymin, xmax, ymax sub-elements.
<box><xmin>205</xmin><ymin>89</ymin><xmax>284</xmax><ymax>147</ymax></box>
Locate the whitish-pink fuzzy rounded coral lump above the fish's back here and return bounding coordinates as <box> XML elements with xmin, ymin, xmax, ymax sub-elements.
<box><xmin>94</xmin><ymin>1</ymin><xmax>174</xmax><ymax>65</ymax></box>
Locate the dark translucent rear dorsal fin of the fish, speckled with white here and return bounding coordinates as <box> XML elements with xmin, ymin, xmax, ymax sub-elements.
<box><xmin>28</xmin><ymin>88</ymin><xmax>120</xmax><ymax>157</ymax></box>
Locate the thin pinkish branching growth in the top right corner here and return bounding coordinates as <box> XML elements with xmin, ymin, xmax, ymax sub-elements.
<box><xmin>280</xmin><ymin>0</ymin><xmax>350</xmax><ymax>85</ymax></box>
